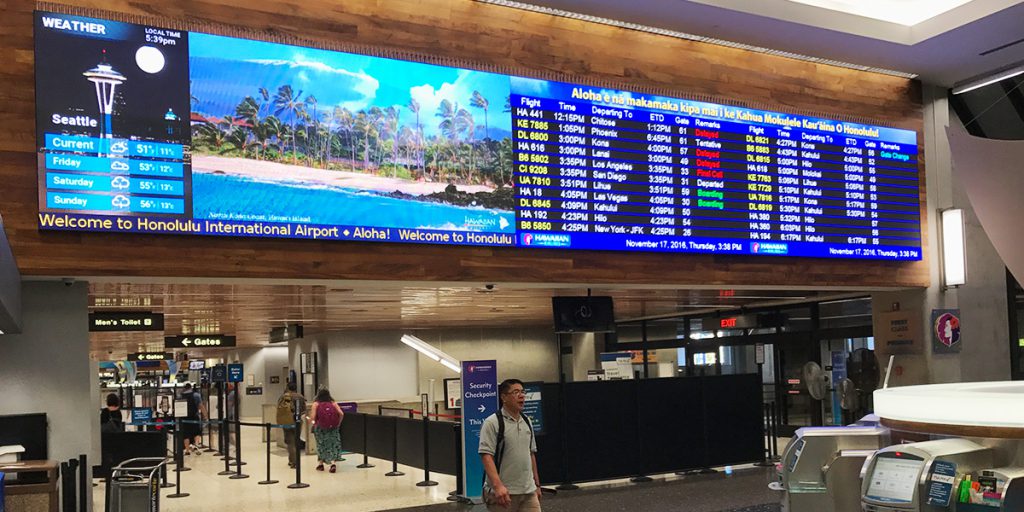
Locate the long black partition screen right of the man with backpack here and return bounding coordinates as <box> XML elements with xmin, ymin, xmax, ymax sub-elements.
<box><xmin>538</xmin><ymin>374</ymin><xmax>764</xmax><ymax>484</ymax></box>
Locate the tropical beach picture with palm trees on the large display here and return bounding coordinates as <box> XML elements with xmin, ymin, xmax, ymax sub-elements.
<box><xmin>188</xmin><ymin>33</ymin><xmax>515</xmax><ymax>232</ymax></box>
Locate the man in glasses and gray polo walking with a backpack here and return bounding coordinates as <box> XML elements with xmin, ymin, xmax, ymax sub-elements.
<box><xmin>477</xmin><ymin>379</ymin><xmax>541</xmax><ymax>512</ymax></box>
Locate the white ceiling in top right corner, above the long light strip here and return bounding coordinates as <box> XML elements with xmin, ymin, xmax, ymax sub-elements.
<box><xmin>524</xmin><ymin>0</ymin><xmax>1024</xmax><ymax>87</ymax></box>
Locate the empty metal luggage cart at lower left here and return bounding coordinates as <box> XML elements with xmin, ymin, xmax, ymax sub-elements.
<box><xmin>106</xmin><ymin>457</ymin><xmax>167</xmax><ymax>512</ymax></box>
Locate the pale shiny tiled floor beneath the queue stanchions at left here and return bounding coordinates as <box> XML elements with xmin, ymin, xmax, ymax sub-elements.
<box><xmin>93</xmin><ymin>423</ymin><xmax>456</xmax><ymax>512</ymax></box>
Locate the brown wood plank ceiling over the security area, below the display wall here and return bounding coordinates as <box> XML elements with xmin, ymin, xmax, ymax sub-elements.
<box><xmin>83</xmin><ymin>283</ymin><xmax>818</xmax><ymax>359</ymax></box>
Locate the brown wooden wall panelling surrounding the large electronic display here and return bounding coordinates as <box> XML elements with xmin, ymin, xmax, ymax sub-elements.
<box><xmin>0</xmin><ymin>0</ymin><xmax>929</xmax><ymax>288</ymax></box>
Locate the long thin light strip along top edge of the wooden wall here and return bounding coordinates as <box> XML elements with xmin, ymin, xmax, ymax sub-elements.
<box><xmin>476</xmin><ymin>0</ymin><xmax>917</xmax><ymax>79</ymax></box>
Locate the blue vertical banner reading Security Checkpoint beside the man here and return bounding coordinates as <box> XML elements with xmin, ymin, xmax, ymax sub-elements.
<box><xmin>462</xmin><ymin>360</ymin><xmax>499</xmax><ymax>504</ymax></box>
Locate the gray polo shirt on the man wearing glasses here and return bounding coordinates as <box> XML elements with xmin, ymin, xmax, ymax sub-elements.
<box><xmin>478</xmin><ymin>408</ymin><xmax>537</xmax><ymax>495</ymax></box>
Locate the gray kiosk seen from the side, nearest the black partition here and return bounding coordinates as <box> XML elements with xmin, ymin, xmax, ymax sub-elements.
<box><xmin>781</xmin><ymin>426</ymin><xmax>889</xmax><ymax>512</ymax></box>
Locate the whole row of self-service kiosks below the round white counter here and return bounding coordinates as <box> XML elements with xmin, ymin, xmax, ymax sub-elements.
<box><xmin>780</xmin><ymin>425</ymin><xmax>1024</xmax><ymax>512</ymax></box>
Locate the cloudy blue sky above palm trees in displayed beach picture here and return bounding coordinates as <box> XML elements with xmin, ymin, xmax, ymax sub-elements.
<box><xmin>188</xmin><ymin>33</ymin><xmax>512</xmax><ymax>138</ymax></box>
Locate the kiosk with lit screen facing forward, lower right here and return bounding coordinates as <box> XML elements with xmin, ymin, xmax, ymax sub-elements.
<box><xmin>861</xmin><ymin>438</ymin><xmax>995</xmax><ymax>512</ymax></box>
